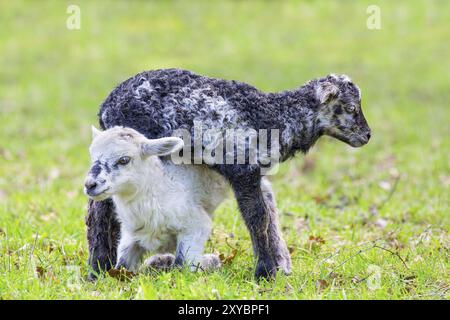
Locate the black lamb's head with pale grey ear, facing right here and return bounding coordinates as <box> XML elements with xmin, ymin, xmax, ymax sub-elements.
<box><xmin>314</xmin><ymin>74</ymin><xmax>371</xmax><ymax>147</ymax></box>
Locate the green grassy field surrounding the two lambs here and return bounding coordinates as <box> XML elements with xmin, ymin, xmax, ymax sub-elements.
<box><xmin>0</xmin><ymin>0</ymin><xmax>450</xmax><ymax>299</ymax></box>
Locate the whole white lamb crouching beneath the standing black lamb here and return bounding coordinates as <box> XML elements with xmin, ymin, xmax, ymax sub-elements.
<box><xmin>85</xmin><ymin>127</ymin><xmax>228</xmax><ymax>271</ymax></box>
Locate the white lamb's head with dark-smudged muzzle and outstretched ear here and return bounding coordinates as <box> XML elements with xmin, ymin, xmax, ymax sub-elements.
<box><xmin>84</xmin><ymin>127</ymin><xmax>183</xmax><ymax>201</ymax></box>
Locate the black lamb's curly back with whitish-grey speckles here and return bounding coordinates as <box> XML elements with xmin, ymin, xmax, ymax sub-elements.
<box><xmin>99</xmin><ymin>69</ymin><xmax>266</xmax><ymax>138</ymax></box>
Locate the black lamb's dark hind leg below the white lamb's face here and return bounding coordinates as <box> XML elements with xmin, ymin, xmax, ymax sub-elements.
<box><xmin>86</xmin><ymin>199</ymin><xmax>120</xmax><ymax>280</ymax></box>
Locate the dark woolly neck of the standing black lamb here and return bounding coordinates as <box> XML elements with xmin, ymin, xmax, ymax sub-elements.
<box><xmin>266</xmin><ymin>83</ymin><xmax>321</xmax><ymax>161</ymax></box>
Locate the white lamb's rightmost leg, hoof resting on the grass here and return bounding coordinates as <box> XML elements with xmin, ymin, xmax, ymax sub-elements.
<box><xmin>175</xmin><ymin>213</ymin><xmax>221</xmax><ymax>271</ymax></box>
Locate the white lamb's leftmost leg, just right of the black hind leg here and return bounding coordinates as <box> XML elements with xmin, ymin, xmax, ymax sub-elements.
<box><xmin>115</xmin><ymin>228</ymin><xmax>145</xmax><ymax>272</ymax></box>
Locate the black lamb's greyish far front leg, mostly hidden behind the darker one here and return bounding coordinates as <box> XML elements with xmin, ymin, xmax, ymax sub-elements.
<box><xmin>261</xmin><ymin>178</ymin><xmax>291</xmax><ymax>274</ymax></box>
